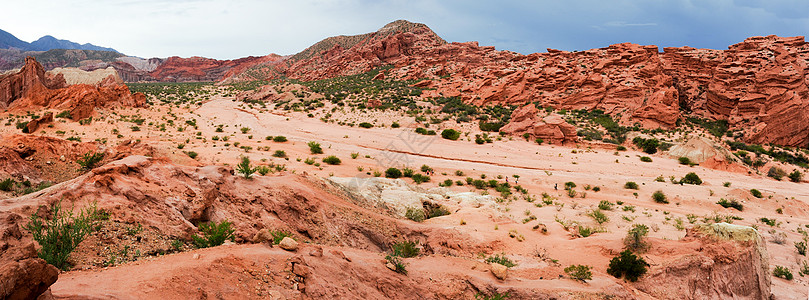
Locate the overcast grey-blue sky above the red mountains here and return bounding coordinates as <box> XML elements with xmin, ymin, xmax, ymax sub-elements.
<box><xmin>0</xmin><ymin>0</ymin><xmax>809</xmax><ymax>59</ymax></box>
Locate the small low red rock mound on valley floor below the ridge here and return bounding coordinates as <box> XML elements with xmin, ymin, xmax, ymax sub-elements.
<box><xmin>500</xmin><ymin>104</ymin><xmax>578</xmax><ymax>143</ymax></box>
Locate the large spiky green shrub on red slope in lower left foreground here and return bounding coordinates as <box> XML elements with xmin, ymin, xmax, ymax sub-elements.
<box><xmin>25</xmin><ymin>202</ymin><xmax>100</xmax><ymax>271</ymax></box>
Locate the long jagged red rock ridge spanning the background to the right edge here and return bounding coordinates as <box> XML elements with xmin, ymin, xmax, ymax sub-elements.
<box><xmin>227</xmin><ymin>21</ymin><xmax>809</xmax><ymax>147</ymax></box>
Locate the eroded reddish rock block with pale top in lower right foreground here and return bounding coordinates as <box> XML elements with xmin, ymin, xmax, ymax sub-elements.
<box><xmin>635</xmin><ymin>223</ymin><xmax>770</xmax><ymax>299</ymax></box>
